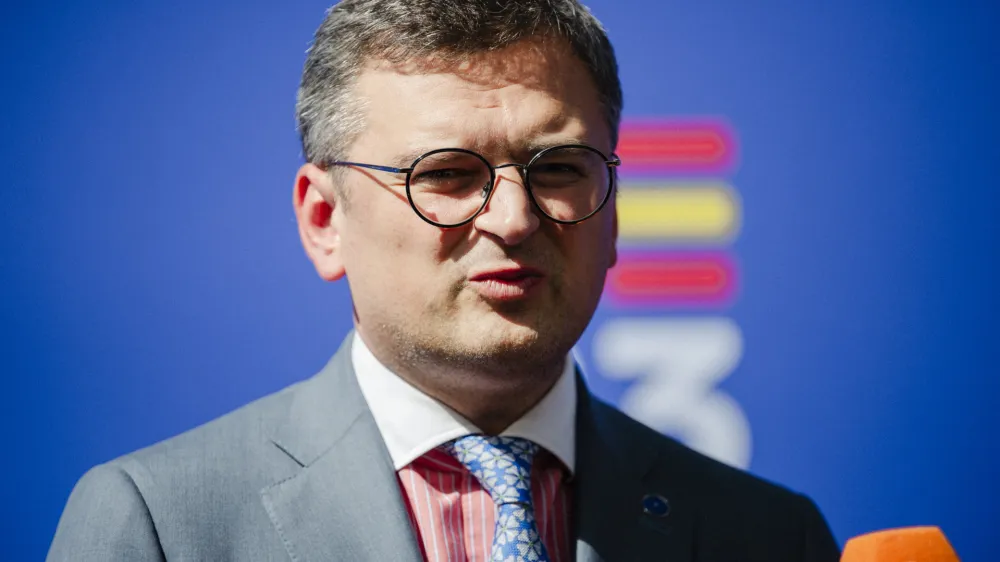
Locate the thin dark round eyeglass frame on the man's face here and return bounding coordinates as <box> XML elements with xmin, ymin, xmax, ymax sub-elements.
<box><xmin>326</xmin><ymin>144</ymin><xmax>622</xmax><ymax>228</ymax></box>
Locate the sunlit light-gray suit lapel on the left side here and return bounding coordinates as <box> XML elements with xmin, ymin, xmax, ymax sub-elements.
<box><xmin>261</xmin><ymin>333</ymin><xmax>422</xmax><ymax>561</ymax></box>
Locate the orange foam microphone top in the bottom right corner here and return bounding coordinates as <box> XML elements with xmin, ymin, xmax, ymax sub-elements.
<box><xmin>840</xmin><ymin>527</ymin><xmax>959</xmax><ymax>562</ymax></box>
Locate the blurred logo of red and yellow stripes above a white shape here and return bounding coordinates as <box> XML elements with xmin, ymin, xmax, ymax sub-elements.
<box><xmin>592</xmin><ymin>117</ymin><xmax>751</xmax><ymax>468</ymax></box>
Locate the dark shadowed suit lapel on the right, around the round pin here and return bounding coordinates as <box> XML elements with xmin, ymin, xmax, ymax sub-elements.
<box><xmin>574</xmin><ymin>372</ymin><xmax>694</xmax><ymax>562</ymax></box>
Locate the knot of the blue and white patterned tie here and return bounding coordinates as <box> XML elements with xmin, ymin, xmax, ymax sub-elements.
<box><xmin>444</xmin><ymin>435</ymin><xmax>539</xmax><ymax>505</ymax></box>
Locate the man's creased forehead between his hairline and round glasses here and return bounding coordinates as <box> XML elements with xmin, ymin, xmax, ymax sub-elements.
<box><xmin>351</xmin><ymin>40</ymin><xmax>610</xmax><ymax>163</ymax></box>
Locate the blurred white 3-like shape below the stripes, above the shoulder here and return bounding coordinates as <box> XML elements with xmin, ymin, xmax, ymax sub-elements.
<box><xmin>593</xmin><ymin>318</ymin><xmax>751</xmax><ymax>468</ymax></box>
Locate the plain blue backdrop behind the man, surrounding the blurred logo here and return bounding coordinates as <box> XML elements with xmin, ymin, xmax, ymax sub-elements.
<box><xmin>0</xmin><ymin>0</ymin><xmax>1000</xmax><ymax>561</ymax></box>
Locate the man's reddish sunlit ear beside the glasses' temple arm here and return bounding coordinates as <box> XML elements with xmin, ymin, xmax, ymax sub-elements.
<box><xmin>292</xmin><ymin>164</ymin><xmax>345</xmax><ymax>281</ymax></box>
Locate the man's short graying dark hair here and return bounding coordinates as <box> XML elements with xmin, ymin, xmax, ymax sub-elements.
<box><xmin>295</xmin><ymin>0</ymin><xmax>622</xmax><ymax>163</ymax></box>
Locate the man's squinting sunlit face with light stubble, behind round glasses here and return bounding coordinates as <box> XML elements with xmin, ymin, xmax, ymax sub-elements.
<box><xmin>300</xmin><ymin>42</ymin><xmax>617</xmax><ymax>368</ymax></box>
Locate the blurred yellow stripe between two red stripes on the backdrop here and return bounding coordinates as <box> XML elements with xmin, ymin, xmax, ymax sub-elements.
<box><xmin>617</xmin><ymin>182</ymin><xmax>742</xmax><ymax>241</ymax></box>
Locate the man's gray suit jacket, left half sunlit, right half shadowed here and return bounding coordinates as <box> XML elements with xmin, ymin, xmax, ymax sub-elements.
<box><xmin>48</xmin><ymin>337</ymin><xmax>839</xmax><ymax>562</ymax></box>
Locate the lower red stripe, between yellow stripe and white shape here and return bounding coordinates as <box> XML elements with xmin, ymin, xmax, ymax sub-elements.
<box><xmin>605</xmin><ymin>252</ymin><xmax>738</xmax><ymax>308</ymax></box>
